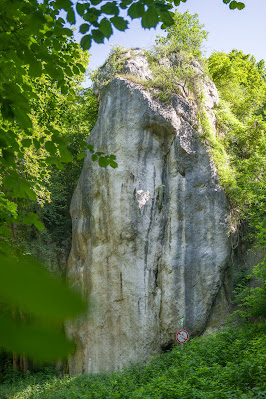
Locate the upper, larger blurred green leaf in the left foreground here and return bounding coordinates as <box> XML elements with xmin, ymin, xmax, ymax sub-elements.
<box><xmin>0</xmin><ymin>253</ymin><xmax>85</xmax><ymax>321</ymax></box>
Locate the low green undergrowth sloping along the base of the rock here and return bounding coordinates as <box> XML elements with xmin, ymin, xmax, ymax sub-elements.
<box><xmin>0</xmin><ymin>323</ymin><xmax>266</xmax><ymax>399</ymax></box>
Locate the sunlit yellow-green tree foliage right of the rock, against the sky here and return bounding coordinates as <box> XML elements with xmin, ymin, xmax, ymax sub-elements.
<box><xmin>208</xmin><ymin>50</ymin><xmax>266</xmax><ymax>226</ymax></box>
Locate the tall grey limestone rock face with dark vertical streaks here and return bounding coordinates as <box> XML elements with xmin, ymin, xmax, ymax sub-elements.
<box><xmin>68</xmin><ymin>50</ymin><xmax>230</xmax><ymax>374</ymax></box>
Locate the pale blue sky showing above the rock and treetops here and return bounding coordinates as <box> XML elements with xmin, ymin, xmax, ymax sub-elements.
<box><xmin>79</xmin><ymin>0</ymin><xmax>266</xmax><ymax>86</ymax></box>
